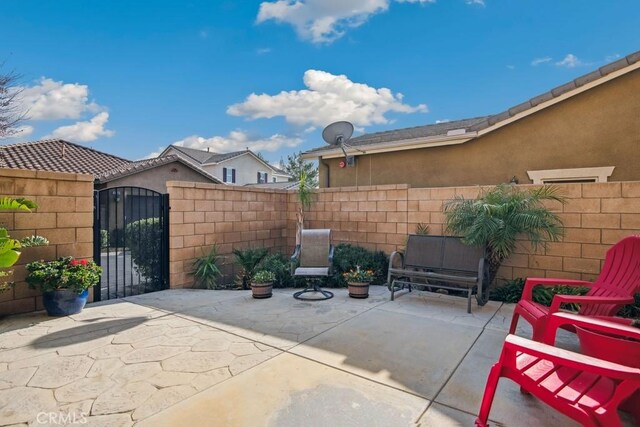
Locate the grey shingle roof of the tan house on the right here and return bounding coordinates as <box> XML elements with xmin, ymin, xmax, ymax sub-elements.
<box><xmin>306</xmin><ymin>51</ymin><xmax>640</xmax><ymax>154</ymax></box>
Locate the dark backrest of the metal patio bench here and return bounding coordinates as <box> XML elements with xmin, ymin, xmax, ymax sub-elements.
<box><xmin>404</xmin><ymin>234</ymin><xmax>485</xmax><ymax>272</ymax></box>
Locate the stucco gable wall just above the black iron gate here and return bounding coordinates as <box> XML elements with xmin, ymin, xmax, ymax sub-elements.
<box><xmin>96</xmin><ymin>162</ymin><xmax>211</xmax><ymax>194</ymax></box>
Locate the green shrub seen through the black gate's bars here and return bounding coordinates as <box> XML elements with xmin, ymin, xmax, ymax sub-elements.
<box><xmin>124</xmin><ymin>218</ymin><xmax>162</xmax><ymax>283</ymax></box>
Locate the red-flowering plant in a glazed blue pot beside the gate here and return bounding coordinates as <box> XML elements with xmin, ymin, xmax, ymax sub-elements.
<box><xmin>26</xmin><ymin>256</ymin><xmax>102</xmax><ymax>316</ymax></box>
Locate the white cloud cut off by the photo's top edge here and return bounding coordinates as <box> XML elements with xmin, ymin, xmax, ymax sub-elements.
<box><xmin>256</xmin><ymin>0</ymin><xmax>435</xmax><ymax>43</ymax></box>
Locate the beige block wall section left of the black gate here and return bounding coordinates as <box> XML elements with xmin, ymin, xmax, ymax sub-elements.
<box><xmin>0</xmin><ymin>169</ymin><xmax>93</xmax><ymax>316</ymax></box>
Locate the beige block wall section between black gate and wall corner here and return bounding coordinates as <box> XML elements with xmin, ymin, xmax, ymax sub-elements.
<box><xmin>167</xmin><ymin>181</ymin><xmax>289</xmax><ymax>288</ymax></box>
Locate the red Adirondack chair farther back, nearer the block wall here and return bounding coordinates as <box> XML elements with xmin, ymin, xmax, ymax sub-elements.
<box><xmin>509</xmin><ymin>236</ymin><xmax>640</xmax><ymax>341</ymax></box>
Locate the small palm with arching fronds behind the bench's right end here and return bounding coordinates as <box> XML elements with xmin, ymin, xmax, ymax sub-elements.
<box><xmin>444</xmin><ymin>184</ymin><xmax>565</xmax><ymax>284</ymax></box>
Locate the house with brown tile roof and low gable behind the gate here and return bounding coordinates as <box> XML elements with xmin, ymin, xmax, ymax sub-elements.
<box><xmin>0</xmin><ymin>139</ymin><xmax>221</xmax><ymax>193</ymax></box>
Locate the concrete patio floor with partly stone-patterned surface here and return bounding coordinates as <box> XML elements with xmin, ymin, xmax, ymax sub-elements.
<box><xmin>0</xmin><ymin>287</ymin><xmax>632</xmax><ymax>427</ymax></box>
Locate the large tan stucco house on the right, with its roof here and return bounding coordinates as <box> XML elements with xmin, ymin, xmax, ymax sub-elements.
<box><xmin>303</xmin><ymin>52</ymin><xmax>640</xmax><ymax>187</ymax></box>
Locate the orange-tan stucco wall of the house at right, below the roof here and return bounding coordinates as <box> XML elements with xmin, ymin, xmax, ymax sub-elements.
<box><xmin>320</xmin><ymin>70</ymin><xmax>640</xmax><ymax>187</ymax></box>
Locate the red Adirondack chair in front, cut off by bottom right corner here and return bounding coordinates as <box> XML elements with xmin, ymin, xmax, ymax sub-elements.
<box><xmin>476</xmin><ymin>313</ymin><xmax>640</xmax><ymax>427</ymax></box>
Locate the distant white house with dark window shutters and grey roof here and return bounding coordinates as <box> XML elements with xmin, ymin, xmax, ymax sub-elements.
<box><xmin>158</xmin><ymin>145</ymin><xmax>290</xmax><ymax>185</ymax></box>
